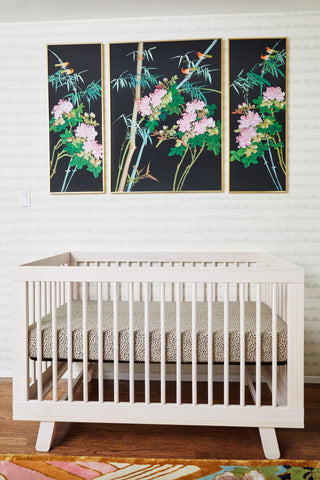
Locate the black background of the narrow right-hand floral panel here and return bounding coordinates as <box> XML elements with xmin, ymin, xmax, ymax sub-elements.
<box><xmin>229</xmin><ymin>38</ymin><xmax>288</xmax><ymax>192</ymax></box>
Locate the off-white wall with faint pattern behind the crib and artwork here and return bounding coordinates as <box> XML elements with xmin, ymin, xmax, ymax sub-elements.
<box><xmin>0</xmin><ymin>12</ymin><xmax>320</xmax><ymax>375</ymax></box>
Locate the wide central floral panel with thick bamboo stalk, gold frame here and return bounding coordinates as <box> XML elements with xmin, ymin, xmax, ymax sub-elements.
<box><xmin>110</xmin><ymin>39</ymin><xmax>222</xmax><ymax>193</ymax></box>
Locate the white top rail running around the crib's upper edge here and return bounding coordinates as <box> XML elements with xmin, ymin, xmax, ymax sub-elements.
<box><xmin>13</xmin><ymin>252</ymin><xmax>304</xmax><ymax>283</ymax></box>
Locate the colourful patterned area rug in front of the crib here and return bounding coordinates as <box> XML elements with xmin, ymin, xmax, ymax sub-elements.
<box><xmin>0</xmin><ymin>455</ymin><xmax>320</xmax><ymax>480</ymax></box>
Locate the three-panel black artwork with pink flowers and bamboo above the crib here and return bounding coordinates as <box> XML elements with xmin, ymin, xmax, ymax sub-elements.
<box><xmin>48</xmin><ymin>38</ymin><xmax>287</xmax><ymax>193</ymax></box>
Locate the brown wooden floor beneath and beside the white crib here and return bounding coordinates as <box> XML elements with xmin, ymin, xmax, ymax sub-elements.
<box><xmin>0</xmin><ymin>379</ymin><xmax>320</xmax><ymax>460</ymax></box>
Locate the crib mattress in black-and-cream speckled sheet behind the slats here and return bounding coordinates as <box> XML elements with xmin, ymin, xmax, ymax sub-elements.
<box><xmin>29</xmin><ymin>300</ymin><xmax>287</xmax><ymax>363</ymax></box>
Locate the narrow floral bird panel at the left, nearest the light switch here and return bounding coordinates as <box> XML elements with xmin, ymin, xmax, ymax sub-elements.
<box><xmin>47</xmin><ymin>44</ymin><xmax>105</xmax><ymax>194</ymax></box>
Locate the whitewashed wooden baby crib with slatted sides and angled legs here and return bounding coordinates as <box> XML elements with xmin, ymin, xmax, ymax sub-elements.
<box><xmin>13</xmin><ymin>252</ymin><xmax>304</xmax><ymax>458</ymax></box>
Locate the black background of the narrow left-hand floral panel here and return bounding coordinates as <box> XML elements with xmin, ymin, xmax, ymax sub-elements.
<box><xmin>48</xmin><ymin>44</ymin><xmax>105</xmax><ymax>193</ymax></box>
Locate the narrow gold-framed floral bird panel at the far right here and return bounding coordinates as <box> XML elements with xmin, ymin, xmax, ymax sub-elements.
<box><xmin>229</xmin><ymin>38</ymin><xmax>288</xmax><ymax>192</ymax></box>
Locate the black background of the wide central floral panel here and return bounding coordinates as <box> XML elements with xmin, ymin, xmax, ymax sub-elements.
<box><xmin>110</xmin><ymin>39</ymin><xmax>222</xmax><ymax>192</ymax></box>
